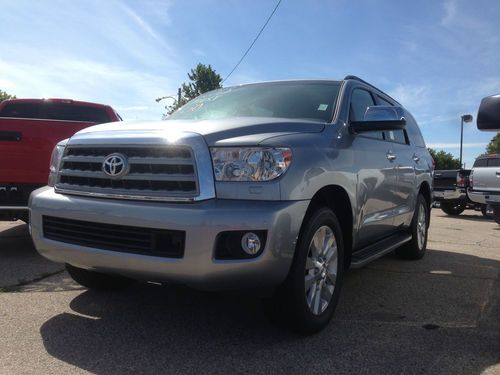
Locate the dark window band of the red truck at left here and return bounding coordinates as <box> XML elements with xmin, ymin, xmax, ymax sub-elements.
<box><xmin>0</xmin><ymin>103</ymin><xmax>110</xmax><ymax>123</ymax></box>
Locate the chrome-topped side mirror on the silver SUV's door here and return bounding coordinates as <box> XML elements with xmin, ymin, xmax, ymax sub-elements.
<box><xmin>350</xmin><ymin>105</ymin><xmax>406</xmax><ymax>133</ymax></box>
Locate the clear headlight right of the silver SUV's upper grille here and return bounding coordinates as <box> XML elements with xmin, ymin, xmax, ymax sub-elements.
<box><xmin>210</xmin><ymin>147</ymin><xmax>292</xmax><ymax>181</ymax></box>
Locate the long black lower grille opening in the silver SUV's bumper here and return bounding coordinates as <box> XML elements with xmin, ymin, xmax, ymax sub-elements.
<box><xmin>42</xmin><ymin>216</ymin><xmax>186</xmax><ymax>258</ymax></box>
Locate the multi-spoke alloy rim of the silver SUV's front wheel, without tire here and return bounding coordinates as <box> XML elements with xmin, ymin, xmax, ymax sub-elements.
<box><xmin>304</xmin><ymin>225</ymin><xmax>338</xmax><ymax>315</ymax></box>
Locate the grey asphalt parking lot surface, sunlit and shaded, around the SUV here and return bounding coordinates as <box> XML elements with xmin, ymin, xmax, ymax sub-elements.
<box><xmin>0</xmin><ymin>209</ymin><xmax>500</xmax><ymax>374</ymax></box>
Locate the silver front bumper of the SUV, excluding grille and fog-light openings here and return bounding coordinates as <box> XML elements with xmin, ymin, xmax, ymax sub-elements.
<box><xmin>30</xmin><ymin>187</ymin><xmax>309</xmax><ymax>289</ymax></box>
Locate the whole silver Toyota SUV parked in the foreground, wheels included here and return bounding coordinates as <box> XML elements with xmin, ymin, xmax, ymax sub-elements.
<box><xmin>30</xmin><ymin>76</ymin><xmax>433</xmax><ymax>334</ymax></box>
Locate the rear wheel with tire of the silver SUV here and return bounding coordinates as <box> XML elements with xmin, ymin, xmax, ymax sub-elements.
<box><xmin>396</xmin><ymin>194</ymin><xmax>429</xmax><ymax>260</ymax></box>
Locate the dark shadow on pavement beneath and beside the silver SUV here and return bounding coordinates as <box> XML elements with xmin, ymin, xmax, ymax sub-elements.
<box><xmin>40</xmin><ymin>250</ymin><xmax>500</xmax><ymax>374</ymax></box>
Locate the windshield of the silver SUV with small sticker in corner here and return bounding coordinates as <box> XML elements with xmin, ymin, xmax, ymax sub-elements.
<box><xmin>167</xmin><ymin>81</ymin><xmax>340</xmax><ymax>122</ymax></box>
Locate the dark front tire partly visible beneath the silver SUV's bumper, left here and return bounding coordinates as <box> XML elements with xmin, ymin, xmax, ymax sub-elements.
<box><xmin>66</xmin><ymin>264</ymin><xmax>136</xmax><ymax>291</ymax></box>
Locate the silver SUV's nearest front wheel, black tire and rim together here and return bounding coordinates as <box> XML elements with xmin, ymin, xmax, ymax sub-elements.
<box><xmin>271</xmin><ymin>207</ymin><xmax>344</xmax><ymax>335</ymax></box>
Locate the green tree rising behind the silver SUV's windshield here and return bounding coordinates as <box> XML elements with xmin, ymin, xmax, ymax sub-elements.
<box><xmin>160</xmin><ymin>63</ymin><xmax>222</xmax><ymax>115</ymax></box>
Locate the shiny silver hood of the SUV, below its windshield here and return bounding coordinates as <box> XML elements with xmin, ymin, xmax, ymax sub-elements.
<box><xmin>76</xmin><ymin>117</ymin><xmax>325</xmax><ymax>146</ymax></box>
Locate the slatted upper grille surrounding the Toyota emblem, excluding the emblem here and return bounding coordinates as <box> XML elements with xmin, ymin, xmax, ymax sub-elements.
<box><xmin>56</xmin><ymin>145</ymin><xmax>199</xmax><ymax>200</ymax></box>
